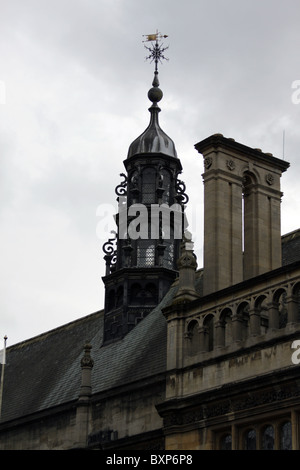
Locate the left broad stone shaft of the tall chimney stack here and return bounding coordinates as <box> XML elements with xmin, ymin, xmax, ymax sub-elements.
<box><xmin>199</xmin><ymin>151</ymin><xmax>243</xmax><ymax>295</ymax></box>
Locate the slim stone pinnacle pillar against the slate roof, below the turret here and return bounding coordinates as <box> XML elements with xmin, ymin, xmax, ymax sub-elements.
<box><xmin>74</xmin><ymin>344</ymin><xmax>94</xmax><ymax>448</ymax></box>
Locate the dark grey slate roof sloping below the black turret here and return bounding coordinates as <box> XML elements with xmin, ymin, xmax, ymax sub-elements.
<box><xmin>1</xmin><ymin>287</ymin><xmax>177</xmax><ymax>423</ymax></box>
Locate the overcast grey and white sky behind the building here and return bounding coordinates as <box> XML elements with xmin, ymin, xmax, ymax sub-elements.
<box><xmin>0</xmin><ymin>0</ymin><xmax>300</xmax><ymax>345</ymax></box>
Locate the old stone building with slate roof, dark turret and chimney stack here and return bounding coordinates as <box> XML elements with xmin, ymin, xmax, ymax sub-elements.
<box><xmin>0</xmin><ymin>60</ymin><xmax>300</xmax><ymax>451</ymax></box>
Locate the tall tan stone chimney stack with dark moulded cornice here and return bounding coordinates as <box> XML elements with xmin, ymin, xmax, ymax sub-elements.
<box><xmin>195</xmin><ymin>134</ymin><xmax>289</xmax><ymax>295</ymax></box>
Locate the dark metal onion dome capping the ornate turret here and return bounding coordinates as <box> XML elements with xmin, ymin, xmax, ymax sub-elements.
<box><xmin>127</xmin><ymin>71</ymin><xmax>177</xmax><ymax>158</ymax></box>
